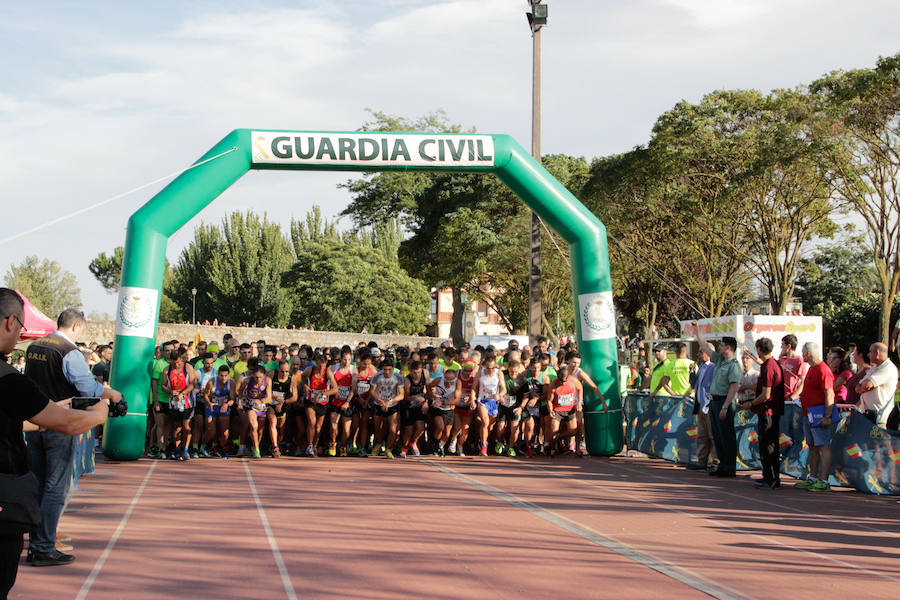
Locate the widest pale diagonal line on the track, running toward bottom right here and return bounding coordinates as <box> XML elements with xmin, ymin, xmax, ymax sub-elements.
<box><xmin>419</xmin><ymin>458</ymin><xmax>750</xmax><ymax>600</ymax></box>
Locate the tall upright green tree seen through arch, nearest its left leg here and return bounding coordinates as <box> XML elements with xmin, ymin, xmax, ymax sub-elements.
<box><xmin>173</xmin><ymin>212</ymin><xmax>293</xmax><ymax>326</ymax></box>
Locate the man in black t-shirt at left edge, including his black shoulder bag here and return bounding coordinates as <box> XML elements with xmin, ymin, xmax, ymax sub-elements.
<box><xmin>0</xmin><ymin>288</ymin><xmax>109</xmax><ymax>598</ymax></box>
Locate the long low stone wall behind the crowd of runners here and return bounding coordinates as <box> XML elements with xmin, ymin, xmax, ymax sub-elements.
<box><xmin>82</xmin><ymin>321</ymin><xmax>445</xmax><ymax>348</ymax></box>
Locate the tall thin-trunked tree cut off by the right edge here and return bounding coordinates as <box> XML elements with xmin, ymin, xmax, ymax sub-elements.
<box><xmin>811</xmin><ymin>54</ymin><xmax>900</xmax><ymax>342</ymax></box>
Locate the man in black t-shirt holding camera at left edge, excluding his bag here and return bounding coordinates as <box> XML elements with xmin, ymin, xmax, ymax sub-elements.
<box><xmin>0</xmin><ymin>288</ymin><xmax>115</xmax><ymax>598</ymax></box>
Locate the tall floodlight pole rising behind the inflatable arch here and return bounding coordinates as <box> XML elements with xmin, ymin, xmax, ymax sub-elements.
<box><xmin>525</xmin><ymin>0</ymin><xmax>547</xmax><ymax>344</ymax></box>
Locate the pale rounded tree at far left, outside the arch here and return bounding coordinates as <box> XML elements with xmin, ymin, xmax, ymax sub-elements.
<box><xmin>5</xmin><ymin>256</ymin><xmax>81</xmax><ymax>319</ymax></box>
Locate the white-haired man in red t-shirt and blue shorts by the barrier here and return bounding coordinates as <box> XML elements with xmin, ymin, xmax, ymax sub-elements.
<box><xmin>796</xmin><ymin>342</ymin><xmax>836</xmax><ymax>492</ymax></box>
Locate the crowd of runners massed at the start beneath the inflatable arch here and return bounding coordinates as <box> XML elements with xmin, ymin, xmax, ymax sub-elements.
<box><xmin>139</xmin><ymin>334</ymin><xmax>606</xmax><ymax>461</ymax></box>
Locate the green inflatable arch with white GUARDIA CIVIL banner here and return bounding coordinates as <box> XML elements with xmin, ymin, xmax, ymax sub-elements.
<box><xmin>103</xmin><ymin>129</ymin><xmax>623</xmax><ymax>460</ymax></box>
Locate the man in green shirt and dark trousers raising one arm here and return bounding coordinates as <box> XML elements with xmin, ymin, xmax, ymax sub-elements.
<box><xmin>692</xmin><ymin>321</ymin><xmax>742</xmax><ymax>477</ymax></box>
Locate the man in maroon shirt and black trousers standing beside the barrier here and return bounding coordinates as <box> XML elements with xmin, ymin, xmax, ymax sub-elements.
<box><xmin>741</xmin><ymin>338</ymin><xmax>784</xmax><ymax>489</ymax></box>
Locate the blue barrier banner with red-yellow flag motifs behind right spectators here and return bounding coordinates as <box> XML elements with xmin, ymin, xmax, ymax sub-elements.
<box><xmin>624</xmin><ymin>394</ymin><xmax>900</xmax><ymax>495</ymax></box>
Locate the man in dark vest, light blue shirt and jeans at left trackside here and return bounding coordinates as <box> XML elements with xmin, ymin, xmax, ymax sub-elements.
<box><xmin>25</xmin><ymin>308</ymin><xmax>122</xmax><ymax>567</ymax></box>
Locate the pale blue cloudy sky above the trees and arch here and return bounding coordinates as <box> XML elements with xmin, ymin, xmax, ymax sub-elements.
<box><xmin>0</xmin><ymin>0</ymin><xmax>900</xmax><ymax>313</ymax></box>
